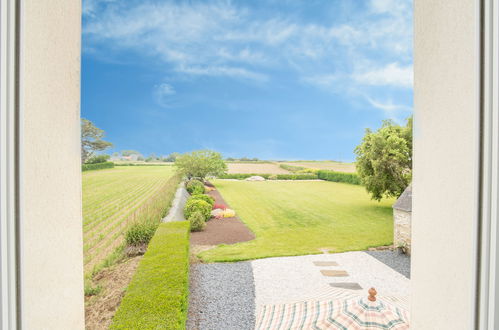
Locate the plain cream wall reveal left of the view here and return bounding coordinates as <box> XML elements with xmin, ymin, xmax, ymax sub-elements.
<box><xmin>21</xmin><ymin>0</ymin><xmax>84</xmax><ymax>329</ymax></box>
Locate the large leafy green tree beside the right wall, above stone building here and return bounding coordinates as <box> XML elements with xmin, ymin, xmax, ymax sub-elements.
<box><xmin>355</xmin><ymin>117</ymin><xmax>412</xmax><ymax>201</ymax></box>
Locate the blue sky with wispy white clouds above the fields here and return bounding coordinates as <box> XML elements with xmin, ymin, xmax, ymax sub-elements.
<box><xmin>81</xmin><ymin>0</ymin><xmax>413</xmax><ymax>161</ymax></box>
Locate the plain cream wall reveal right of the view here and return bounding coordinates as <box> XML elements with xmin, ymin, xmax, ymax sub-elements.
<box><xmin>411</xmin><ymin>0</ymin><xmax>478</xmax><ymax>330</ymax></box>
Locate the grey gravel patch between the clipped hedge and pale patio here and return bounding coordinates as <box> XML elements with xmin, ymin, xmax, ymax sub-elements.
<box><xmin>187</xmin><ymin>262</ymin><xmax>255</xmax><ymax>330</ymax></box>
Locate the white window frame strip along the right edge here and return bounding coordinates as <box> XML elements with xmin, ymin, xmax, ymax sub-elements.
<box><xmin>476</xmin><ymin>0</ymin><xmax>499</xmax><ymax>330</ymax></box>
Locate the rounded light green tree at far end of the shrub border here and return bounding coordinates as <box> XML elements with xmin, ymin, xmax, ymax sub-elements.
<box><xmin>175</xmin><ymin>150</ymin><xmax>227</xmax><ymax>180</ymax></box>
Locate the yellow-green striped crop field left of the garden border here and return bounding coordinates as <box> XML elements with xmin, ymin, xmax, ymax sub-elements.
<box><xmin>83</xmin><ymin>166</ymin><xmax>178</xmax><ymax>272</ymax></box>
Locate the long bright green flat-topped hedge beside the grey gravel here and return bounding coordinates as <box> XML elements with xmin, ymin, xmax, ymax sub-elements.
<box><xmin>110</xmin><ymin>221</ymin><xmax>189</xmax><ymax>329</ymax></box>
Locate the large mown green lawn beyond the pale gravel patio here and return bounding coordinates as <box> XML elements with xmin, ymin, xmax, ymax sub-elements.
<box><xmin>200</xmin><ymin>180</ymin><xmax>395</xmax><ymax>262</ymax></box>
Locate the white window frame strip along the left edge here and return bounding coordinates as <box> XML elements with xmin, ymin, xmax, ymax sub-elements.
<box><xmin>0</xmin><ymin>0</ymin><xmax>20</xmax><ymax>329</ymax></box>
